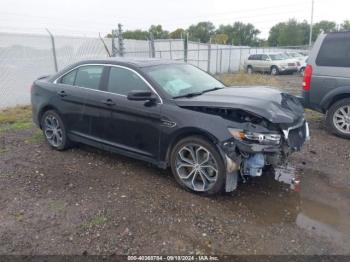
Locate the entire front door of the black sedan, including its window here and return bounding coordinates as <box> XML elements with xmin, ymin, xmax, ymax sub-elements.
<box><xmin>97</xmin><ymin>66</ymin><xmax>161</xmax><ymax>158</ymax></box>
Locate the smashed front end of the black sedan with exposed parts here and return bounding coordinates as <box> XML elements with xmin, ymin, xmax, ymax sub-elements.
<box><xmin>220</xmin><ymin>112</ymin><xmax>309</xmax><ymax>192</ymax></box>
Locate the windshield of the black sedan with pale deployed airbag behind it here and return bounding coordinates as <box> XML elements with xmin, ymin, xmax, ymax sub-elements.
<box><xmin>144</xmin><ymin>64</ymin><xmax>224</xmax><ymax>97</ymax></box>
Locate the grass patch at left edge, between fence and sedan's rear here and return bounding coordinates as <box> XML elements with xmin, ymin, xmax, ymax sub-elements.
<box><xmin>0</xmin><ymin>106</ymin><xmax>33</xmax><ymax>131</ymax></box>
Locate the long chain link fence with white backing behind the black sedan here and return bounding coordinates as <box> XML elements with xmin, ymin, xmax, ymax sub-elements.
<box><xmin>0</xmin><ymin>33</ymin><xmax>304</xmax><ymax>108</ymax></box>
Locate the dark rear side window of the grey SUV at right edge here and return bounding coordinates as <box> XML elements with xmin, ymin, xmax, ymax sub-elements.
<box><xmin>316</xmin><ymin>33</ymin><xmax>350</xmax><ymax>67</ymax></box>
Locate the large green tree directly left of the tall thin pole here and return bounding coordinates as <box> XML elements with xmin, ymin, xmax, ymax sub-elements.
<box><xmin>268</xmin><ymin>19</ymin><xmax>310</xmax><ymax>46</ymax></box>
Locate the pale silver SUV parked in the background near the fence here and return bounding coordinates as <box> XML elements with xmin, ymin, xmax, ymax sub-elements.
<box><xmin>244</xmin><ymin>53</ymin><xmax>298</xmax><ymax>75</ymax></box>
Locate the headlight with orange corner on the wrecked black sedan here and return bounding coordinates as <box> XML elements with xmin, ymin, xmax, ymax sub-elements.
<box><xmin>228</xmin><ymin>128</ymin><xmax>281</xmax><ymax>145</ymax></box>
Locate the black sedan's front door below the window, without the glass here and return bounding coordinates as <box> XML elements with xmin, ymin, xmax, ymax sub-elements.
<box><xmin>99</xmin><ymin>94</ymin><xmax>160</xmax><ymax>158</ymax></box>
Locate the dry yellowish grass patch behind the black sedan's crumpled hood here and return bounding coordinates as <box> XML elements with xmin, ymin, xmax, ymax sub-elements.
<box><xmin>217</xmin><ymin>72</ymin><xmax>279</xmax><ymax>86</ymax></box>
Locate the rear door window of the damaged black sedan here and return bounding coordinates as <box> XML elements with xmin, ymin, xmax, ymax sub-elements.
<box><xmin>74</xmin><ymin>65</ymin><xmax>103</xmax><ymax>89</ymax></box>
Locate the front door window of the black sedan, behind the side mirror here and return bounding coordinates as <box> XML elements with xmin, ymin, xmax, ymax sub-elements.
<box><xmin>107</xmin><ymin>67</ymin><xmax>150</xmax><ymax>95</ymax></box>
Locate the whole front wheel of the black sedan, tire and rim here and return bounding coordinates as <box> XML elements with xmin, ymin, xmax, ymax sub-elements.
<box><xmin>170</xmin><ymin>136</ymin><xmax>226</xmax><ymax>195</ymax></box>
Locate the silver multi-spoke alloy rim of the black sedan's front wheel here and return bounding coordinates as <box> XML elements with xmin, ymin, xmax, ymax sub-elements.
<box><xmin>176</xmin><ymin>144</ymin><xmax>219</xmax><ymax>192</ymax></box>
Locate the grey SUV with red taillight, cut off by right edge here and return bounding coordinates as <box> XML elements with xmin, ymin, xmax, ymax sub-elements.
<box><xmin>303</xmin><ymin>32</ymin><xmax>350</xmax><ymax>138</ymax></box>
